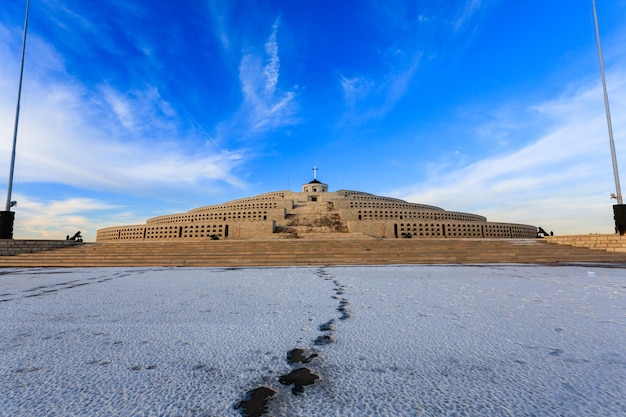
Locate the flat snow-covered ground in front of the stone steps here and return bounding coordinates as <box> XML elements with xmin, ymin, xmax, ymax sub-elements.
<box><xmin>0</xmin><ymin>265</ymin><xmax>626</xmax><ymax>416</ymax></box>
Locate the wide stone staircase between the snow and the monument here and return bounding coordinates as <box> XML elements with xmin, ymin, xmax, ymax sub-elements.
<box><xmin>0</xmin><ymin>239</ymin><xmax>626</xmax><ymax>268</ymax></box>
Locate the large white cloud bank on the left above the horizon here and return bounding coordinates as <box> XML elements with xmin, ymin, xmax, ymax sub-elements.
<box><xmin>0</xmin><ymin>24</ymin><xmax>245</xmax><ymax>202</ymax></box>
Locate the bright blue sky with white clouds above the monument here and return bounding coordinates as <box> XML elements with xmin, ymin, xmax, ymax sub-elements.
<box><xmin>0</xmin><ymin>0</ymin><xmax>626</xmax><ymax>240</ymax></box>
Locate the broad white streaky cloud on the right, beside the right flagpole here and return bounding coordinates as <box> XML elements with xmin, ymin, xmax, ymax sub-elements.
<box><xmin>393</xmin><ymin>72</ymin><xmax>626</xmax><ymax>234</ymax></box>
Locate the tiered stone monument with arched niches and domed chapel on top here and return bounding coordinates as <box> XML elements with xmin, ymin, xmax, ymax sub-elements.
<box><xmin>96</xmin><ymin>179</ymin><xmax>537</xmax><ymax>242</ymax></box>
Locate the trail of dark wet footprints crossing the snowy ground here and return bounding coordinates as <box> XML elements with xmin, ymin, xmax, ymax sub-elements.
<box><xmin>235</xmin><ymin>268</ymin><xmax>352</xmax><ymax>417</ymax></box>
